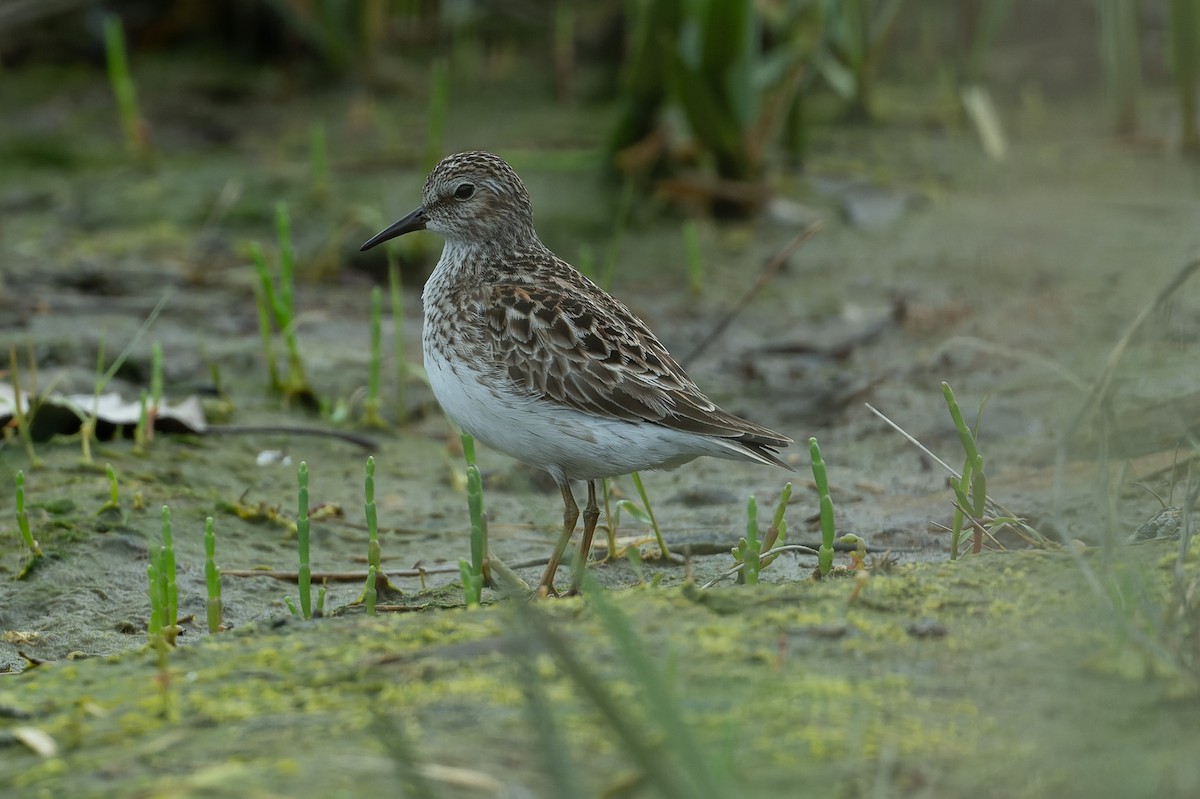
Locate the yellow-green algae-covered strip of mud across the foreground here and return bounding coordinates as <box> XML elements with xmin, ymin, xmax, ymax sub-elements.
<box><xmin>0</xmin><ymin>547</ymin><xmax>1200</xmax><ymax>797</ymax></box>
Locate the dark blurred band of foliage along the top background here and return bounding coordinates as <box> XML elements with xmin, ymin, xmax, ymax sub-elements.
<box><xmin>0</xmin><ymin>0</ymin><xmax>1200</xmax><ymax>216</ymax></box>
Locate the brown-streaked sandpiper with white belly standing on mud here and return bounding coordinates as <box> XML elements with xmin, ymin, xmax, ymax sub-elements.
<box><xmin>362</xmin><ymin>152</ymin><xmax>792</xmax><ymax>594</ymax></box>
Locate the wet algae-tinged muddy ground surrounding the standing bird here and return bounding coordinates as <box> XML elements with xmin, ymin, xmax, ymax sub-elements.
<box><xmin>0</xmin><ymin>59</ymin><xmax>1200</xmax><ymax>797</ymax></box>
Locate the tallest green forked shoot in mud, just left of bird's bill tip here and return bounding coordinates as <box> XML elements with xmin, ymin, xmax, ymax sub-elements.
<box><xmin>250</xmin><ymin>203</ymin><xmax>317</xmax><ymax>405</ymax></box>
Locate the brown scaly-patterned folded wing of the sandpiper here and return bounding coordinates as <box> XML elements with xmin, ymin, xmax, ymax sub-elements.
<box><xmin>485</xmin><ymin>284</ymin><xmax>791</xmax><ymax>449</ymax></box>
